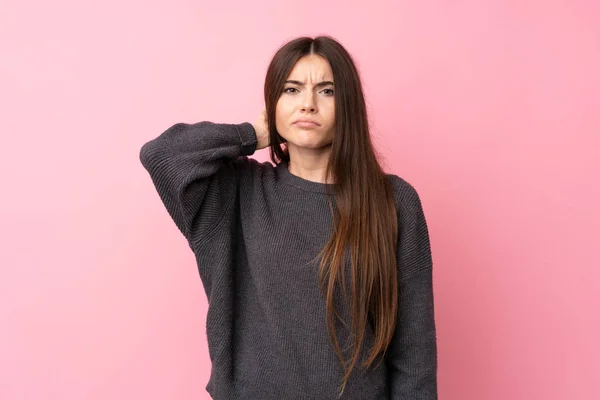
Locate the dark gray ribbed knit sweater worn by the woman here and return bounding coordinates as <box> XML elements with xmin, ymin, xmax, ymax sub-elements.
<box><xmin>140</xmin><ymin>122</ymin><xmax>437</xmax><ymax>400</ymax></box>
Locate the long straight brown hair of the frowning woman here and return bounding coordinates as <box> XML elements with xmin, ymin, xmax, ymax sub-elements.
<box><xmin>265</xmin><ymin>36</ymin><xmax>398</xmax><ymax>393</ymax></box>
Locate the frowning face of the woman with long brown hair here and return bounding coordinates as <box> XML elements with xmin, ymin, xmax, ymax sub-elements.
<box><xmin>275</xmin><ymin>54</ymin><xmax>335</xmax><ymax>150</ymax></box>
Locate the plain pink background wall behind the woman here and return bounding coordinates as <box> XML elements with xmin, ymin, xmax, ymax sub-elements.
<box><xmin>0</xmin><ymin>0</ymin><xmax>600</xmax><ymax>400</ymax></box>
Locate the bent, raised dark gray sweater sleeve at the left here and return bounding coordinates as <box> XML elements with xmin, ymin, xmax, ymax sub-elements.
<box><xmin>140</xmin><ymin>121</ymin><xmax>257</xmax><ymax>240</ymax></box>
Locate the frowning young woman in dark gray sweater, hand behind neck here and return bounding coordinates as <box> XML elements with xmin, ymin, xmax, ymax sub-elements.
<box><xmin>140</xmin><ymin>36</ymin><xmax>437</xmax><ymax>400</ymax></box>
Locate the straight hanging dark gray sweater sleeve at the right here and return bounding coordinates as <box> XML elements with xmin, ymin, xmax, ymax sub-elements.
<box><xmin>387</xmin><ymin>182</ymin><xmax>438</xmax><ymax>400</ymax></box>
